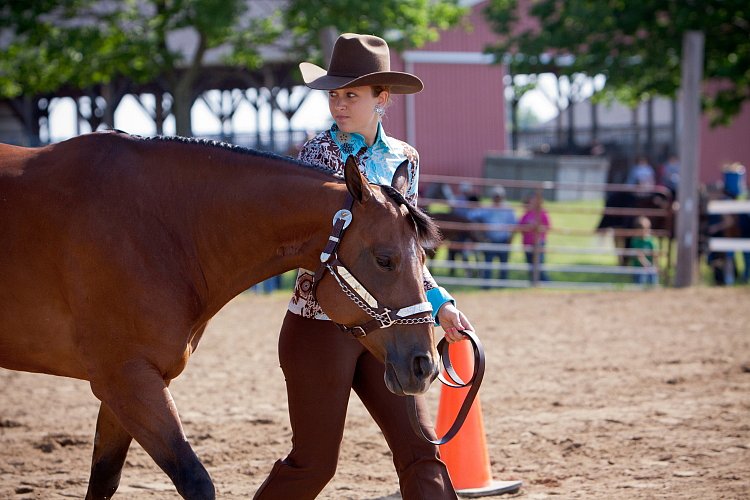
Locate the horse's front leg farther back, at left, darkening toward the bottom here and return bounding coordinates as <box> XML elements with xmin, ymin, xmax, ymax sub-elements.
<box><xmin>86</xmin><ymin>403</ymin><xmax>133</xmax><ymax>500</ymax></box>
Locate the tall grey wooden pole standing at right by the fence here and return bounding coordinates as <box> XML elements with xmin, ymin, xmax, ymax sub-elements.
<box><xmin>674</xmin><ymin>31</ymin><xmax>704</xmax><ymax>288</ymax></box>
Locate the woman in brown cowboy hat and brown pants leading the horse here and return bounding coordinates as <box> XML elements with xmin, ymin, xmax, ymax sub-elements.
<box><xmin>255</xmin><ymin>33</ymin><xmax>473</xmax><ymax>500</ymax></box>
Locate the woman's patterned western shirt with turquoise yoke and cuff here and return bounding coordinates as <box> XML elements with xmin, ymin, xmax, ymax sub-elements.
<box><xmin>289</xmin><ymin>124</ymin><xmax>453</xmax><ymax>320</ymax></box>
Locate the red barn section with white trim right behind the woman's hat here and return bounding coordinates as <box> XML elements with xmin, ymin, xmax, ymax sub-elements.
<box><xmin>384</xmin><ymin>2</ymin><xmax>506</xmax><ymax>177</ymax></box>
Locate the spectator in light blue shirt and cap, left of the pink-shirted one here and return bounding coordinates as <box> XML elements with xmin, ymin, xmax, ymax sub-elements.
<box><xmin>477</xmin><ymin>186</ymin><xmax>516</xmax><ymax>280</ymax></box>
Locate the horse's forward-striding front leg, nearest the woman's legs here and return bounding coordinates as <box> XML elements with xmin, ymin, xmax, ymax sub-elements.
<box><xmin>91</xmin><ymin>360</ymin><xmax>216</xmax><ymax>500</ymax></box>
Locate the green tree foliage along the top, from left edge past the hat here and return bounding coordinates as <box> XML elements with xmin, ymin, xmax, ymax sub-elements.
<box><xmin>0</xmin><ymin>0</ymin><xmax>465</xmax><ymax>135</ymax></box>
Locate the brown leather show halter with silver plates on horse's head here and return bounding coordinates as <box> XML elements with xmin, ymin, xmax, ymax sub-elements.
<box><xmin>311</xmin><ymin>193</ymin><xmax>435</xmax><ymax>338</ymax></box>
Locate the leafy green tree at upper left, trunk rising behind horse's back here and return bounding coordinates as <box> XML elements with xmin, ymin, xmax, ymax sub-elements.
<box><xmin>0</xmin><ymin>0</ymin><xmax>280</xmax><ymax>135</ymax></box>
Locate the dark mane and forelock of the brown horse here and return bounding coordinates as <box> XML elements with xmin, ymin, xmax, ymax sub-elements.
<box><xmin>129</xmin><ymin>134</ymin><xmax>441</xmax><ymax>249</ymax></box>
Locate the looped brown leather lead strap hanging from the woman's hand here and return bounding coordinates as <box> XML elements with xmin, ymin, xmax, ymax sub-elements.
<box><xmin>408</xmin><ymin>330</ymin><xmax>484</xmax><ymax>445</ymax></box>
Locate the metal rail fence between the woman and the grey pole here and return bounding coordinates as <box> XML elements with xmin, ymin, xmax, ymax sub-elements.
<box><xmin>419</xmin><ymin>175</ymin><xmax>674</xmax><ymax>289</ymax></box>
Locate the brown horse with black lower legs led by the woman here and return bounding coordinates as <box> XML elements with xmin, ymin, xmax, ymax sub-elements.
<box><xmin>0</xmin><ymin>132</ymin><xmax>444</xmax><ymax>499</ymax></box>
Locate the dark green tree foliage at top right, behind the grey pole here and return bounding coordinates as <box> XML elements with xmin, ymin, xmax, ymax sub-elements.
<box><xmin>485</xmin><ymin>0</ymin><xmax>750</xmax><ymax>124</ymax></box>
